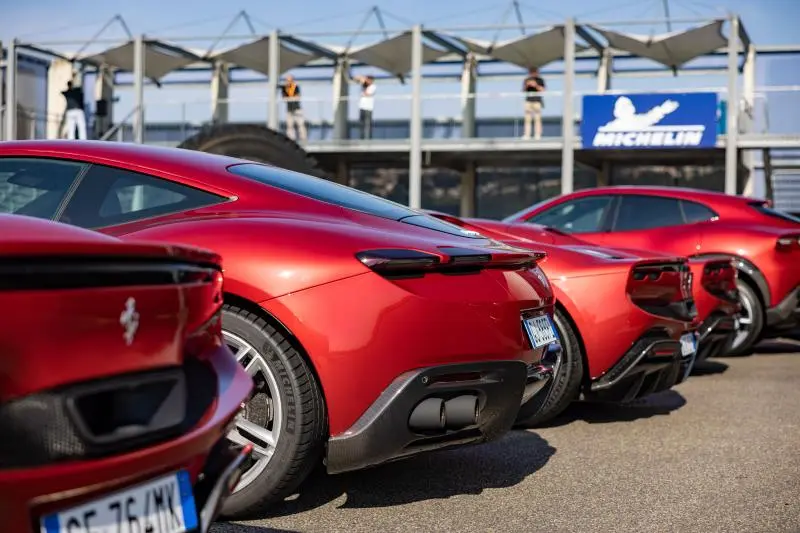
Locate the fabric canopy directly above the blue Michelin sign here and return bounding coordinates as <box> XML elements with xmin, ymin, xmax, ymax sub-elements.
<box><xmin>589</xmin><ymin>20</ymin><xmax>728</xmax><ymax>68</ymax></box>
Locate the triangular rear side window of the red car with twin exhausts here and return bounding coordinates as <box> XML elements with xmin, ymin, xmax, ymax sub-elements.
<box><xmin>62</xmin><ymin>165</ymin><xmax>225</xmax><ymax>228</ymax></box>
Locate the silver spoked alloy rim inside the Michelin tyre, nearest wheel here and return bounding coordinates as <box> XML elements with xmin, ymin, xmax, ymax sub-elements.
<box><xmin>222</xmin><ymin>330</ymin><xmax>283</xmax><ymax>492</ymax></box>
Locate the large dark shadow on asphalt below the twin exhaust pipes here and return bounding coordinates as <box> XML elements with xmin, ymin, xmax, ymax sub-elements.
<box><xmin>250</xmin><ymin>431</ymin><xmax>556</xmax><ymax>516</ymax></box>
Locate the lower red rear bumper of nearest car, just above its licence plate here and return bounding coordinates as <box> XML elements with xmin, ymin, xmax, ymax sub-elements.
<box><xmin>0</xmin><ymin>347</ymin><xmax>252</xmax><ymax>533</ymax></box>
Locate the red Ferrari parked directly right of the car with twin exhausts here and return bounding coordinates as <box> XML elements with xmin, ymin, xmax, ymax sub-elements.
<box><xmin>424</xmin><ymin>213</ymin><xmax>697</xmax><ymax>425</ymax></box>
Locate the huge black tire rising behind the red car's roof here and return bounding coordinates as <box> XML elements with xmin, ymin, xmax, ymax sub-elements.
<box><xmin>178</xmin><ymin>124</ymin><xmax>328</xmax><ymax>178</ymax></box>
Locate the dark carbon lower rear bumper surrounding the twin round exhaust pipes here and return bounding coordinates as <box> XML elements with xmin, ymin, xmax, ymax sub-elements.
<box><xmin>326</xmin><ymin>361</ymin><xmax>532</xmax><ymax>474</ymax></box>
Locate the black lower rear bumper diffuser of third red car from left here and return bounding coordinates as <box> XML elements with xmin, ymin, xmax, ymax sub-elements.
<box><xmin>583</xmin><ymin>330</ymin><xmax>694</xmax><ymax>402</ymax></box>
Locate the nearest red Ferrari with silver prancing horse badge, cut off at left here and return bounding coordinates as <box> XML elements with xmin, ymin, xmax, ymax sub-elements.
<box><xmin>0</xmin><ymin>215</ymin><xmax>253</xmax><ymax>533</ymax></box>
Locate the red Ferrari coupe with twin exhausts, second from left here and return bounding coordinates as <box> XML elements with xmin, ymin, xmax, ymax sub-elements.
<box><xmin>0</xmin><ymin>141</ymin><xmax>555</xmax><ymax>515</ymax></box>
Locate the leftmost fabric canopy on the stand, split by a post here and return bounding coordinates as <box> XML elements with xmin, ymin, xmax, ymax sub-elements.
<box><xmin>82</xmin><ymin>41</ymin><xmax>202</xmax><ymax>80</ymax></box>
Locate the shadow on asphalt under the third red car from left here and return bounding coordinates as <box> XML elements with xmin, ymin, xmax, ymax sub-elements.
<box><xmin>534</xmin><ymin>389</ymin><xmax>686</xmax><ymax>429</ymax></box>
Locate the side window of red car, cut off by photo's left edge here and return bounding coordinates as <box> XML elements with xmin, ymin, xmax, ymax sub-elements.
<box><xmin>0</xmin><ymin>158</ymin><xmax>84</xmax><ymax>219</ymax></box>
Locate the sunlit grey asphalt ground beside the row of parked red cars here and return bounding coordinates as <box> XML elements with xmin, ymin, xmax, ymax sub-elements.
<box><xmin>212</xmin><ymin>341</ymin><xmax>800</xmax><ymax>533</ymax></box>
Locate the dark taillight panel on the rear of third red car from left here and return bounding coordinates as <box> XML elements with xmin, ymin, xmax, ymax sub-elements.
<box><xmin>626</xmin><ymin>262</ymin><xmax>697</xmax><ymax>321</ymax></box>
